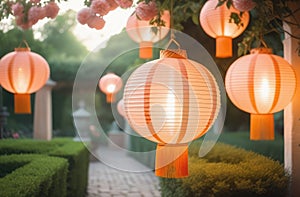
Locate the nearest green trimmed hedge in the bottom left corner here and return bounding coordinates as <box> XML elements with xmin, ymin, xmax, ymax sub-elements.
<box><xmin>0</xmin><ymin>154</ymin><xmax>68</xmax><ymax>197</ymax></box>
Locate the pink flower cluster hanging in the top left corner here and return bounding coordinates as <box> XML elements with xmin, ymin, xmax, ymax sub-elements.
<box><xmin>11</xmin><ymin>0</ymin><xmax>59</xmax><ymax>29</ymax></box>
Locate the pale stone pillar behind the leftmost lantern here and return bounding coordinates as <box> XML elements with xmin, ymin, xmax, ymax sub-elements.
<box><xmin>33</xmin><ymin>79</ymin><xmax>56</xmax><ymax>140</ymax></box>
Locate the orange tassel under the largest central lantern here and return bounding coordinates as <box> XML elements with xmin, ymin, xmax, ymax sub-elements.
<box><xmin>155</xmin><ymin>144</ymin><xmax>188</xmax><ymax>178</ymax></box>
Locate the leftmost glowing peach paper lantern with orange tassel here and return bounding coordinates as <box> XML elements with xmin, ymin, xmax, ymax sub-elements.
<box><xmin>0</xmin><ymin>48</ymin><xmax>50</xmax><ymax>113</ymax></box>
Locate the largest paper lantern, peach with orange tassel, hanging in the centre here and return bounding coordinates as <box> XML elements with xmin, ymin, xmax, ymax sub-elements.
<box><xmin>124</xmin><ymin>50</ymin><xmax>220</xmax><ymax>178</ymax></box>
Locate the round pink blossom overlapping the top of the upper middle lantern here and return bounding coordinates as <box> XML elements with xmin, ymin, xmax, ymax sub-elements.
<box><xmin>135</xmin><ymin>1</ymin><xmax>158</xmax><ymax>21</ymax></box>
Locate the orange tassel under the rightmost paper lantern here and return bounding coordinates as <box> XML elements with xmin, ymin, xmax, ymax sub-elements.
<box><xmin>250</xmin><ymin>114</ymin><xmax>274</xmax><ymax>140</ymax></box>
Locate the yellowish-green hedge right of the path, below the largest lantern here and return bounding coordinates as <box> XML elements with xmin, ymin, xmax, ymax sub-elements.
<box><xmin>160</xmin><ymin>142</ymin><xmax>289</xmax><ymax>197</ymax></box>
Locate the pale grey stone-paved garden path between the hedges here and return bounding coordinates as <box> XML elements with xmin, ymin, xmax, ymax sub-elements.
<box><xmin>87</xmin><ymin>145</ymin><xmax>161</xmax><ymax>197</ymax></box>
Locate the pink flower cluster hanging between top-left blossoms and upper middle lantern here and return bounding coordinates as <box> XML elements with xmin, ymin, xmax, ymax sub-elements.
<box><xmin>77</xmin><ymin>0</ymin><xmax>133</xmax><ymax>30</ymax></box>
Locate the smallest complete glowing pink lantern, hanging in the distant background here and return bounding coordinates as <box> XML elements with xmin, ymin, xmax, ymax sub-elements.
<box><xmin>99</xmin><ymin>73</ymin><xmax>123</xmax><ymax>103</ymax></box>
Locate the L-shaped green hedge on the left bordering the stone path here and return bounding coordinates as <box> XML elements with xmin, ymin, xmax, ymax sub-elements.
<box><xmin>0</xmin><ymin>138</ymin><xmax>89</xmax><ymax>197</ymax></box>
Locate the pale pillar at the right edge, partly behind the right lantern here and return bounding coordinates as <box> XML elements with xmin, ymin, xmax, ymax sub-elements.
<box><xmin>283</xmin><ymin>4</ymin><xmax>300</xmax><ymax>197</ymax></box>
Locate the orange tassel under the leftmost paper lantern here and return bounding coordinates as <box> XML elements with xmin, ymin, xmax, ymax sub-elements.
<box><xmin>14</xmin><ymin>94</ymin><xmax>31</xmax><ymax>114</ymax></box>
